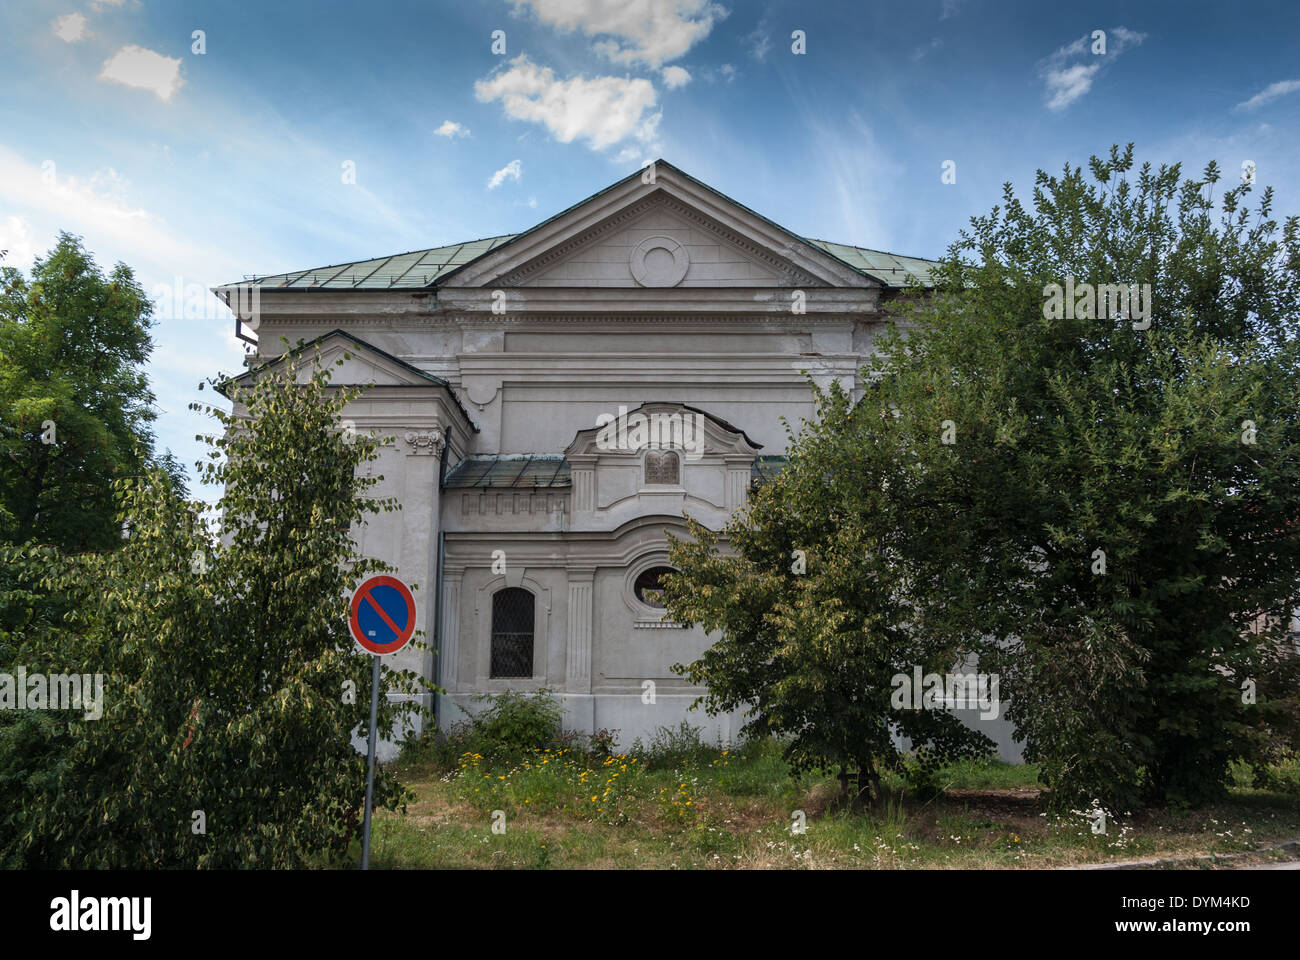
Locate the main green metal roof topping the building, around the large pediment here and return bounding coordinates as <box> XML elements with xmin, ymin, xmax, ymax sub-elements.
<box><xmin>217</xmin><ymin>160</ymin><xmax>935</xmax><ymax>290</ymax></box>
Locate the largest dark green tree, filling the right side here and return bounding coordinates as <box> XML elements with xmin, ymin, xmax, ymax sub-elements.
<box><xmin>677</xmin><ymin>146</ymin><xmax>1300</xmax><ymax>810</ymax></box>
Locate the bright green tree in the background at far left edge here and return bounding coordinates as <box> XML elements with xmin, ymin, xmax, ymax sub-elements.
<box><xmin>0</xmin><ymin>233</ymin><xmax>167</xmax><ymax>553</ymax></box>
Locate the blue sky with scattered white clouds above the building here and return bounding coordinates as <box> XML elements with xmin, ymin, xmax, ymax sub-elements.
<box><xmin>0</xmin><ymin>0</ymin><xmax>1300</xmax><ymax>492</ymax></box>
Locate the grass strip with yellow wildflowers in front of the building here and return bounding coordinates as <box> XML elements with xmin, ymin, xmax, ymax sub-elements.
<box><xmin>348</xmin><ymin>738</ymin><xmax>1300</xmax><ymax>869</ymax></box>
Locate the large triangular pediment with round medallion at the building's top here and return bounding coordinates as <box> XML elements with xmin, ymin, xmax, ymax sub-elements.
<box><xmin>438</xmin><ymin>160</ymin><xmax>880</xmax><ymax>289</ymax></box>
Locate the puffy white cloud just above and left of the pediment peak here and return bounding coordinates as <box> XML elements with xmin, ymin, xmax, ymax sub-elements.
<box><xmin>475</xmin><ymin>53</ymin><xmax>660</xmax><ymax>150</ymax></box>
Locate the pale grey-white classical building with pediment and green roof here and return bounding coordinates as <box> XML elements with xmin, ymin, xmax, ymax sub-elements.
<box><xmin>217</xmin><ymin>161</ymin><xmax>977</xmax><ymax>743</ymax></box>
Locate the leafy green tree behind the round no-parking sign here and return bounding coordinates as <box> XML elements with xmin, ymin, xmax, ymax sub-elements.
<box><xmin>0</xmin><ymin>348</ymin><xmax>423</xmax><ymax>868</ymax></box>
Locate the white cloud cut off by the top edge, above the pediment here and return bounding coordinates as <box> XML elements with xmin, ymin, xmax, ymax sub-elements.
<box><xmin>511</xmin><ymin>0</ymin><xmax>727</xmax><ymax>68</ymax></box>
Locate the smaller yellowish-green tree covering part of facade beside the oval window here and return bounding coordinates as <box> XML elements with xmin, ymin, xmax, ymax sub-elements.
<box><xmin>662</xmin><ymin>377</ymin><xmax>992</xmax><ymax>801</ymax></box>
